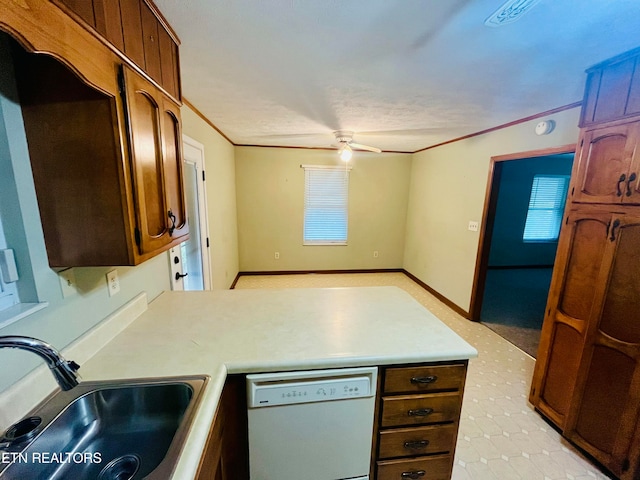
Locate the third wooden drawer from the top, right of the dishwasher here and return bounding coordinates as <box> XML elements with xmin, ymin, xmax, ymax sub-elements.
<box><xmin>378</xmin><ymin>424</ymin><xmax>458</xmax><ymax>459</ymax></box>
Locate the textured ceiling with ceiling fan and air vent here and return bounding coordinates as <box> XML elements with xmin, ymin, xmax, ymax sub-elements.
<box><xmin>155</xmin><ymin>0</ymin><xmax>640</xmax><ymax>152</ymax></box>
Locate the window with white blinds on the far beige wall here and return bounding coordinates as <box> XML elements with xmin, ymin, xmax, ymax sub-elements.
<box><xmin>302</xmin><ymin>165</ymin><xmax>350</xmax><ymax>245</ymax></box>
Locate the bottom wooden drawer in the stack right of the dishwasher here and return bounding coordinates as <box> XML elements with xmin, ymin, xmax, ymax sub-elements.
<box><xmin>377</xmin><ymin>455</ymin><xmax>452</xmax><ymax>480</ymax></box>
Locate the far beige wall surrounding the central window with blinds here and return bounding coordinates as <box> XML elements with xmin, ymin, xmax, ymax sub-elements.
<box><xmin>236</xmin><ymin>147</ymin><xmax>411</xmax><ymax>272</ymax></box>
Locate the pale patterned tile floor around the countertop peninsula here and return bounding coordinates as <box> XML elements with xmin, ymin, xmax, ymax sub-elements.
<box><xmin>235</xmin><ymin>273</ymin><xmax>610</xmax><ymax>480</ymax></box>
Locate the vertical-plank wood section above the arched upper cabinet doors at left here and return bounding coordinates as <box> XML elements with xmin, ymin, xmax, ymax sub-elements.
<box><xmin>51</xmin><ymin>0</ymin><xmax>182</xmax><ymax>102</ymax></box>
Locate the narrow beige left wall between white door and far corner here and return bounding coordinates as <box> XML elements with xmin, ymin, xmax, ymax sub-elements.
<box><xmin>180</xmin><ymin>106</ymin><xmax>238</xmax><ymax>289</ymax></box>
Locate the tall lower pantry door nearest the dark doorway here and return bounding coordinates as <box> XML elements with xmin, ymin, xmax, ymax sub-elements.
<box><xmin>530</xmin><ymin>212</ymin><xmax>611</xmax><ymax>428</ymax></box>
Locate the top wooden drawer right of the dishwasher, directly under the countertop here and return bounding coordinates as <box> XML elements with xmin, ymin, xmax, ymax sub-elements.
<box><xmin>383</xmin><ymin>365</ymin><xmax>466</xmax><ymax>393</ymax></box>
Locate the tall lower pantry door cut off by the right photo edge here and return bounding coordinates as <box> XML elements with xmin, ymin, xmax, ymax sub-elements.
<box><xmin>566</xmin><ymin>214</ymin><xmax>640</xmax><ymax>478</ymax></box>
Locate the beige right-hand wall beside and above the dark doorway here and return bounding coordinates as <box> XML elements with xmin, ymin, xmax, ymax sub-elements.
<box><xmin>404</xmin><ymin>108</ymin><xmax>580</xmax><ymax>311</ymax></box>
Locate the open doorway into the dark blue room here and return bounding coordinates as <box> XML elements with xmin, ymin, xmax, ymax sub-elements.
<box><xmin>470</xmin><ymin>145</ymin><xmax>575</xmax><ymax>357</ymax></box>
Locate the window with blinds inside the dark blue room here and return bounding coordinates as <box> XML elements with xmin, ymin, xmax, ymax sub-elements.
<box><xmin>522</xmin><ymin>175</ymin><xmax>569</xmax><ymax>242</ymax></box>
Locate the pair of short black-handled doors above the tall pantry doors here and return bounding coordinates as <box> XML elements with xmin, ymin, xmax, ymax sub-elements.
<box><xmin>571</xmin><ymin>122</ymin><xmax>640</xmax><ymax>204</ymax></box>
